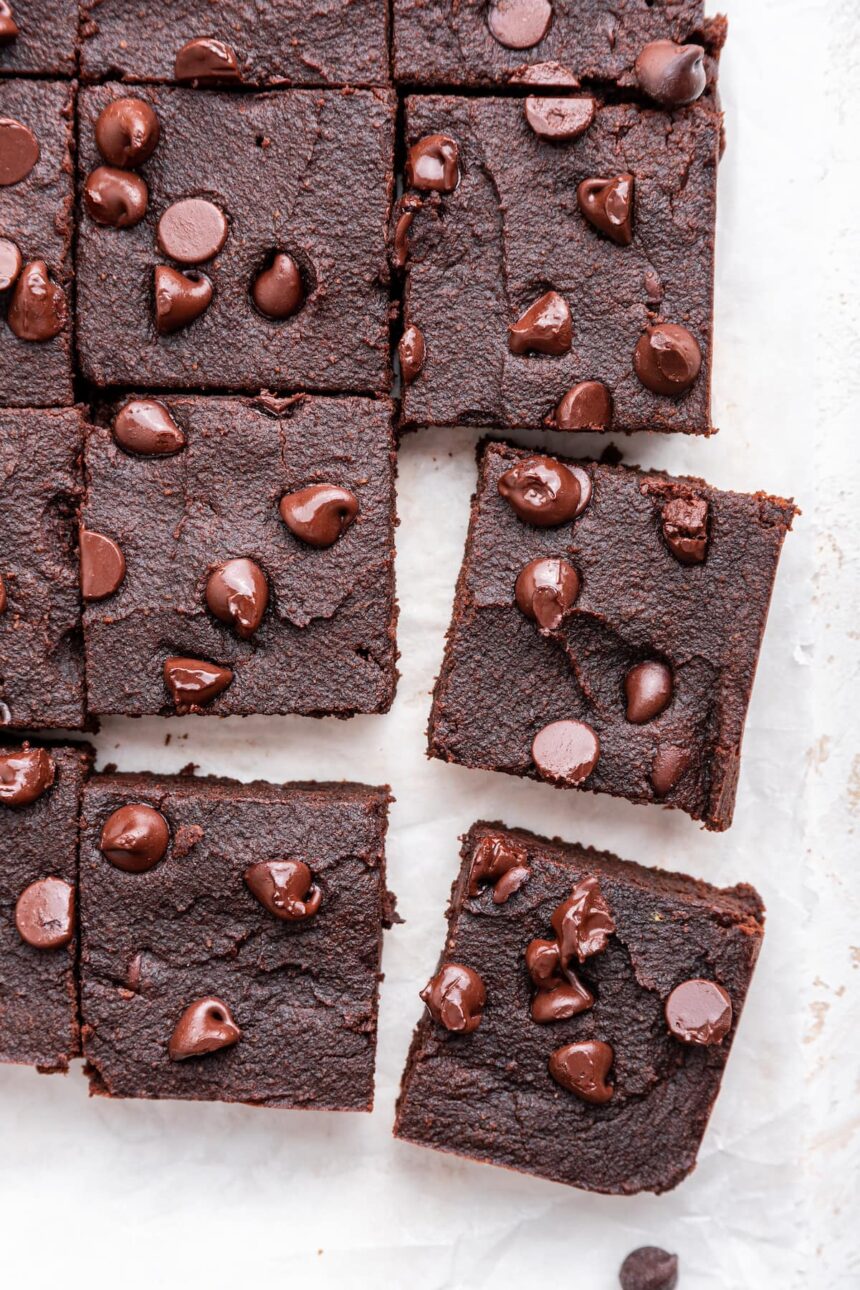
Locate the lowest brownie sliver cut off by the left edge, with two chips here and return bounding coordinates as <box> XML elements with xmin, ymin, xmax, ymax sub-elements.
<box><xmin>0</xmin><ymin>740</ymin><xmax>92</xmax><ymax>1071</ymax></box>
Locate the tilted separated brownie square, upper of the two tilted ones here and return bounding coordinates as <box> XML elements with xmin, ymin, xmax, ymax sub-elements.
<box><xmin>429</xmin><ymin>442</ymin><xmax>796</xmax><ymax>829</ymax></box>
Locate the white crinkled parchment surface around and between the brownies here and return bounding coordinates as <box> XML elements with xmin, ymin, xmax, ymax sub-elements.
<box><xmin>0</xmin><ymin>0</ymin><xmax>860</xmax><ymax>1290</ymax></box>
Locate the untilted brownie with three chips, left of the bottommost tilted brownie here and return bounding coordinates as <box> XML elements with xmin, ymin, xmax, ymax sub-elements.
<box><xmin>80</xmin><ymin>775</ymin><xmax>393</xmax><ymax>1111</ymax></box>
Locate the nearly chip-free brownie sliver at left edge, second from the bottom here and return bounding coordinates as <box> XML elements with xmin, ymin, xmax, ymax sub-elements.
<box><xmin>0</xmin><ymin>408</ymin><xmax>84</xmax><ymax>730</ymax></box>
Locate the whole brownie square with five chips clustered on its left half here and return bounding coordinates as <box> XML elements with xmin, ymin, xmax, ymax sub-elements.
<box><xmin>77</xmin><ymin>84</ymin><xmax>393</xmax><ymax>393</ymax></box>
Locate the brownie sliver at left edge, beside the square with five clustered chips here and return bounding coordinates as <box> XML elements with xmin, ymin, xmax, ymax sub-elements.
<box><xmin>0</xmin><ymin>80</ymin><xmax>73</xmax><ymax>408</ymax></box>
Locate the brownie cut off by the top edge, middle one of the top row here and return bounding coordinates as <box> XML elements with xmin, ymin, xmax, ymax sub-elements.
<box><xmin>81</xmin><ymin>0</ymin><xmax>389</xmax><ymax>85</ymax></box>
